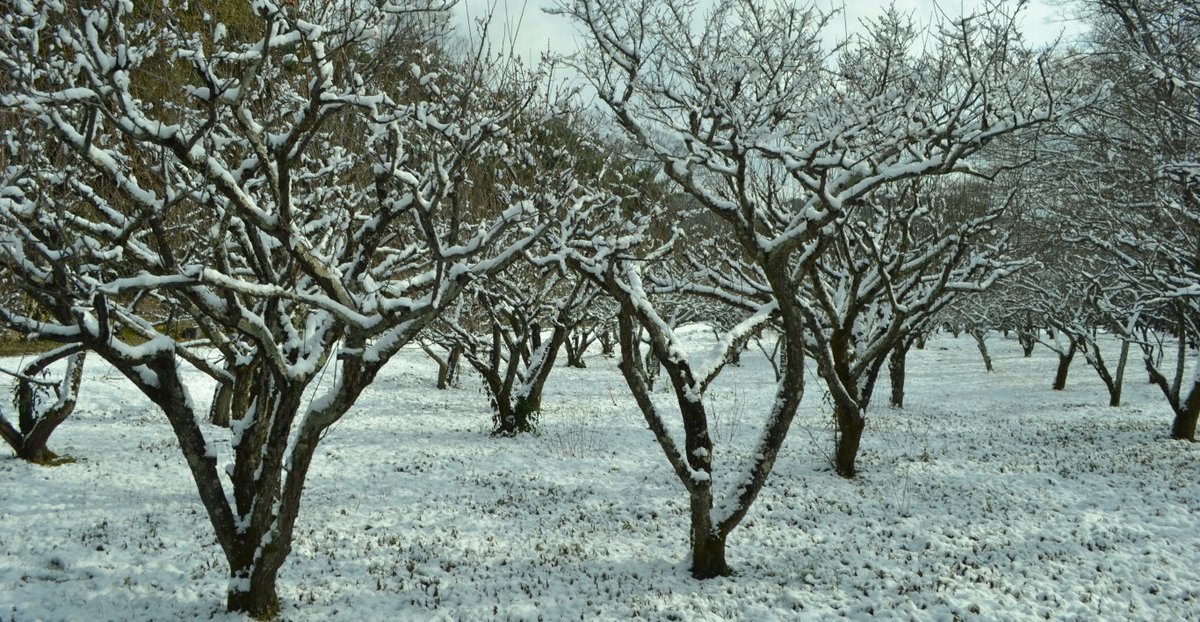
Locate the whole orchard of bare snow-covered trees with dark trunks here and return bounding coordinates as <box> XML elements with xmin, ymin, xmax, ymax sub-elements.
<box><xmin>0</xmin><ymin>0</ymin><xmax>1200</xmax><ymax>617</ymax></box>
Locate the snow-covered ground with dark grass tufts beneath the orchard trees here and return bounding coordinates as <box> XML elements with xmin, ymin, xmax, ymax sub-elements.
<box><xmin>0</xmin><ymin>334</ymin><xmax>1200</xmax><ymax>621</ymax></box>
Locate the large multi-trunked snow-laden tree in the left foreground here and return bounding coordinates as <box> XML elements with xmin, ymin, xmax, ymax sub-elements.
<box><xmin>0</xmin><ymin>0</ymin><xmax>566</xmax><ymax>617</ymax></box>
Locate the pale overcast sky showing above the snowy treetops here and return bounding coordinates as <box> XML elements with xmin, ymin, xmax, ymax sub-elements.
<box><xmin>456</xmin><ymin>0</ymin><xmax>1081</xmax><ymax>59</ymax></box>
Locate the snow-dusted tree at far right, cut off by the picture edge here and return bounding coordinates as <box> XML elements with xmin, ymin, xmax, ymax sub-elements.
<box><xmin>1045</xmin><ymin>0</ymin><xmax>1200</xmax><ymax>439</ymax></box>
